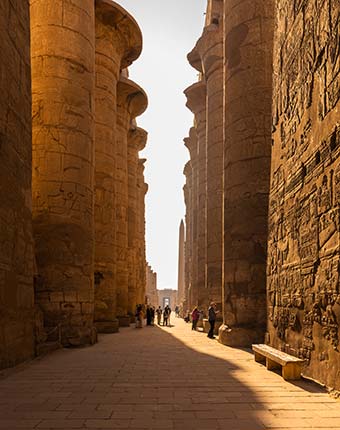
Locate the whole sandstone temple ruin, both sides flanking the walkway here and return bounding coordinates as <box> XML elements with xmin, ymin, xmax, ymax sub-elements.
<box><xmin>0</xmin><ymin>0</ymin><xmax>340</xmax><ymax>398</ymax></box>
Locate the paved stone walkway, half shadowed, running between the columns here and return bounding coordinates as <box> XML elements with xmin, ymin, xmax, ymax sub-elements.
<box><xmin>0</xmin><ymin>318</ymin><xmax>340</xmax><ymax>430</ymax></box>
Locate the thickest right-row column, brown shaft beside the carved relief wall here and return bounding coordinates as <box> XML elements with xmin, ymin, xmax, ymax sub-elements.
<box><xmin>220</xmin><ymin>0</ymin><xmax>274</xmax><ymax>346</ymax></box>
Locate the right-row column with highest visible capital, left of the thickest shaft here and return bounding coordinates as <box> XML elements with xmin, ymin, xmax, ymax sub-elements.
<box><xmin>188</xmin><ymin>0</ymin><xmax>224</xmax><ymax>310</ymax></box>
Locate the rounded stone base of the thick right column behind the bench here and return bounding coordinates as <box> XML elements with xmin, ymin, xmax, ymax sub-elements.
<box><xmin>218</xmin><ymin>324</ymin><xmax>264</xmax><ymax>348</ymax></box>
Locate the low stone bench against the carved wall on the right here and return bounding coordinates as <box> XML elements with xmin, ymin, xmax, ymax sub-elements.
<box><xmin>252</xmin><ymin>344</ymin><xmax>303</xmax><ymax>381</ymax></box>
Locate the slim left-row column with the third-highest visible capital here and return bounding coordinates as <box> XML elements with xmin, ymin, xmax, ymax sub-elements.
<box><xmin>128</xmin><ymin>126</ymin><xmax>147</xmax><ymax>318</ymax></box>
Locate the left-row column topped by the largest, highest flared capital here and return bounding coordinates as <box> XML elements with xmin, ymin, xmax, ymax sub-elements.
<box><xmin>94</xmin><ymin>0</ymin><xmax>142</xmax><ymax>332</ymax></box>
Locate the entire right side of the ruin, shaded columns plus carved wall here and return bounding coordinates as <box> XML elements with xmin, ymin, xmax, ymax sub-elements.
<box><xmin>182</xmin><ymin>0</ymin><xmax>340</xmax><ymax>390</ymax></box>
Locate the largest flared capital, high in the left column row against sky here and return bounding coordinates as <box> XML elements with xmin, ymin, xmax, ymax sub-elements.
<box><xmin>96</xmin><ymin>0</ymin><xmax>143</xmax><ymax>68</ymax></box>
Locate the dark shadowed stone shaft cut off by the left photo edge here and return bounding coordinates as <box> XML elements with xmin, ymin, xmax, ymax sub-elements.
<box><xmin>0</xmin><ymin>0</ymin><xmax>34</xmax><ymax>369</ymax></box>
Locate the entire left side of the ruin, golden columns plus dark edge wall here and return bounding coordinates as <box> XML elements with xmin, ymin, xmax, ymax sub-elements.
<box><xmin>0</xmin><ymin>0</ymin><xmax>148</xmax><ymax>362</ymax></box>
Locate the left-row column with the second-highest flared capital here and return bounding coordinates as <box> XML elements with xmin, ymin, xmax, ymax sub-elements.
<box><xmin>115</xmin><ymin>76</ymin><xmax>147</xmax><ymax>325</ymax></box>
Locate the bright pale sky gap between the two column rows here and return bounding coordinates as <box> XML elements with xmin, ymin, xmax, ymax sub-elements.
<box><xmin>116</xmin><ymin>0</ymin><xmax>207</xmax><ymax>289</ymax></box>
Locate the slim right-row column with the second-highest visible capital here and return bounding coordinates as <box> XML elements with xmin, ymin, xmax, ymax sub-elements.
<box><xmin>185</xmin><ymin>81</ymin><xmax>207</xmax><ymax>307</ymax></box>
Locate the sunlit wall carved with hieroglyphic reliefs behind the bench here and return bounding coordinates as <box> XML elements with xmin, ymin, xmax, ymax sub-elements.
<box><xmin>267</xmin><ymin>0</ymin><xmax>340</xmax><ymax>390</ymax></box>
